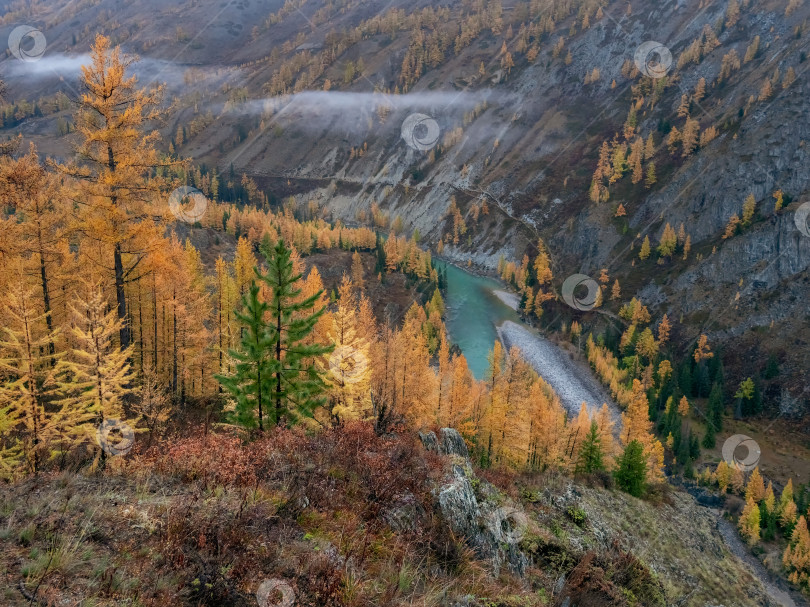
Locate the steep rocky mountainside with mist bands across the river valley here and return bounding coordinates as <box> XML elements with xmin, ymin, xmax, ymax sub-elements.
<box><xmin>0</xmin><ymin>0</ymin><xmax>810</xmax><ymax>399</ymax></box>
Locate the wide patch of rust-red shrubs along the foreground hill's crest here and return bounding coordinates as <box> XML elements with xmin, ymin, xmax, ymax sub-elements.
<box><xmin>132</xmin><ymin>422</ymin><xmax>438</xmax><ymax>521</ymax></box>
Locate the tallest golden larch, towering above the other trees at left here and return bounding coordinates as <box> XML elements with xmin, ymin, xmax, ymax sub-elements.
<box><xmin>62</xmin><ymin>34</ymin><xmax>167</xmax><ymax>349</ymax></box>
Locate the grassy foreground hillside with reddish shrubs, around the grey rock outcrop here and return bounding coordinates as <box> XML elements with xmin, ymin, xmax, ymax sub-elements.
<box><xmin>0</xmin><ymin>423</ymin><xmax>775</xmax><ymax>607</ymax></box>
